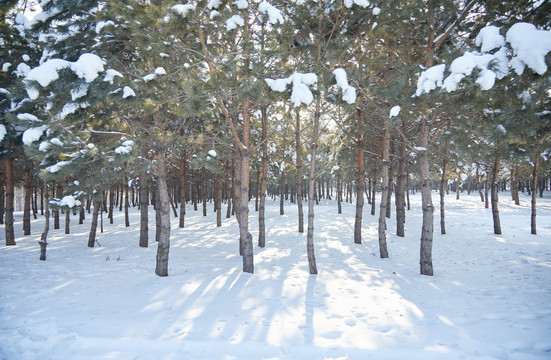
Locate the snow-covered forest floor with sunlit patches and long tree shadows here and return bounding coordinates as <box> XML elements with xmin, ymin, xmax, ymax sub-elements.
<box><xmin>0</xmin><ymin>193</ymin><xmax>551</xmax><ymax>360</ymax></box>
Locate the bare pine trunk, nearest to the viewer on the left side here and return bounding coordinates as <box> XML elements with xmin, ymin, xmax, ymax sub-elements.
<box><xmin>155</xmin><ymin>152</ymin><xmax>170</xmax><ymax>276</ymax></box>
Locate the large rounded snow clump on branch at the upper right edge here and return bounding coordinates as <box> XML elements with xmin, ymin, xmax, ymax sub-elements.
<box><xmin>506</xmin><ymin>22</ymin><xmax>551</xmax><ymax>75</ymax></box>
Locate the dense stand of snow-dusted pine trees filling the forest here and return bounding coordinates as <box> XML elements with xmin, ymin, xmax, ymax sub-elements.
<box><xmin>0</xmin><ymin>0</ymin><xmax>551</xmax><ymax>276</ymax></box>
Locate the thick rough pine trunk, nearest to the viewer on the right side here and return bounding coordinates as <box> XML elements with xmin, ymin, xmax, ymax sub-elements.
<box><xmin>419</xmin><ymin>110</ymin><xmax>434</xmax><ymax>276</ymax></box>
